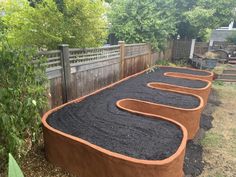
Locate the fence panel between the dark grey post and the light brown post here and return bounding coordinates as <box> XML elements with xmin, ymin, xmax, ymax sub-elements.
<box><xmin>69</xmin><ymin>46</ymin><xmax>120</xmax><ymax>100</ymax></box>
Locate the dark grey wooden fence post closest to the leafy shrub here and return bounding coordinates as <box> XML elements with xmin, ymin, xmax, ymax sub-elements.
<box><xmin>58</xmin><ymin>44</ymin><xmax>71</xmax><ymax>103</ymax></box>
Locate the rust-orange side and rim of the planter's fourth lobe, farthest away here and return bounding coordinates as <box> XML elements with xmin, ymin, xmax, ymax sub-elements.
<box><xmin>163</xmin><ymin>66</ymin><xmax>214</xmax><ymax>82</ymax></box>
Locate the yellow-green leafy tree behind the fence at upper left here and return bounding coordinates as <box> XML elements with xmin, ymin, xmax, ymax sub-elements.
<box><xmin>2</xmin><ymin>0</ymin><xmax>63</xmax><ymax>49</ymax></box>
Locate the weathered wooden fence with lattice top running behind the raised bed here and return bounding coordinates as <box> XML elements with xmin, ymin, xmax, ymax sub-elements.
<box><xmin>40</xmin><ymin>42</ymin><xmax>172</xmax><ymax>108</ymax></box>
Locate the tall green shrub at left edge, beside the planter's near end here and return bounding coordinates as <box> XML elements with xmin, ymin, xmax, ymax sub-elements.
<box><xmin>0</xmin><ymin>43</ymin><xmax>47</xmax><ymax>171</ymax></box>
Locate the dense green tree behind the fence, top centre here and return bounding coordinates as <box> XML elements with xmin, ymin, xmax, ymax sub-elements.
<box><xmin>109</xmin><ymin>0</ymin><xmax>176</xmax><ymax>49</ymax></box>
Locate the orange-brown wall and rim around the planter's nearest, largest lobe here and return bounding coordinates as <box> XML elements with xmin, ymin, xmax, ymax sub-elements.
<box><xmin>42</xmin><ymin>108</ymin><xmax>188</xmax><ymax>177</ymax></box>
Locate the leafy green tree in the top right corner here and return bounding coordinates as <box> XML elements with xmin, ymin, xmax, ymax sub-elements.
<box><xmin>175</xmin><ymin>0</ymin><xmax>236</xmax><ymax>39</ymax></box>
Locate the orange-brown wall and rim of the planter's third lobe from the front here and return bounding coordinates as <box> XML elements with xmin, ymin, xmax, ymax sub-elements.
<box><xmin>148</xmin><ymin>78</ymin><xmax>212</xmax><ymax>107</ymax></box>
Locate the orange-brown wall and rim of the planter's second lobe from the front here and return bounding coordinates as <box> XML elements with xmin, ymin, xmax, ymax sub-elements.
<box><xmin>116</xmin><ymin>91</ymin><xmax>204</xmax><ymax>140</ymax></box>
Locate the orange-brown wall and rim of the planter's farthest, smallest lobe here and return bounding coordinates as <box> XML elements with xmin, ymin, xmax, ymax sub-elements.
<box><xmin>161</xmin><ymin>66</ymin><xmax>214</xmax><ymax>82</ymax></box>
